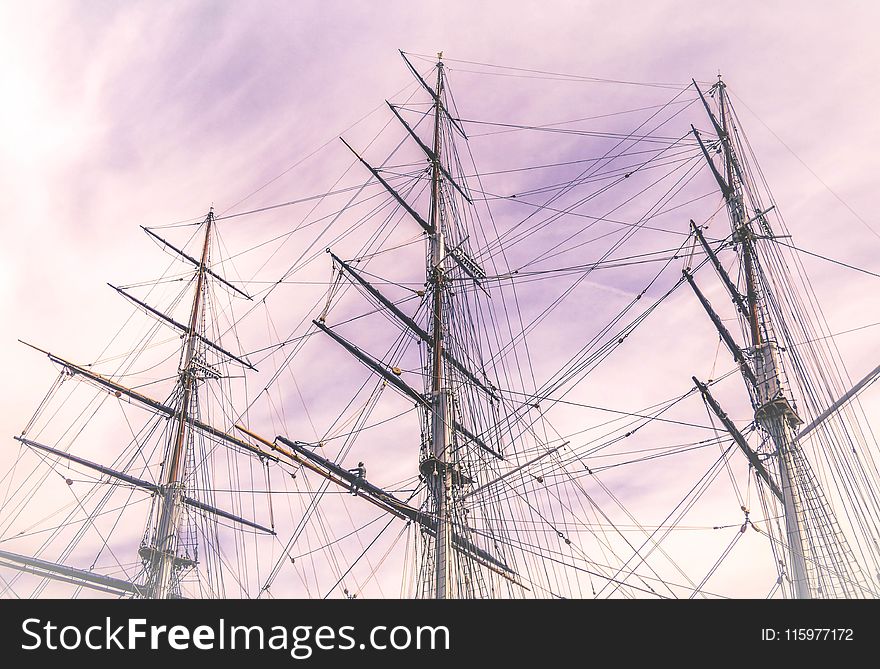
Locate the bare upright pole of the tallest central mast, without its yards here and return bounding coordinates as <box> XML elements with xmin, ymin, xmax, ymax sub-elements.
<box><xmin>429</xmin><ymin>52</ymin><xmax>452</xmax><ymax>599</ymax></box>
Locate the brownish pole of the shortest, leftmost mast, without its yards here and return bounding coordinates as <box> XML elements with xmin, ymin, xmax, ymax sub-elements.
<box><xmin>140</xmin><ymin>207</ymin><xmax>214</xmax><ymax>599</ymax></box>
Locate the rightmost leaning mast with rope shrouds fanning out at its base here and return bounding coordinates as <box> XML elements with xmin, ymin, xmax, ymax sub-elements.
<box><xmin>692</xmin><ymin>77</ymin><xmax>864</xmax><ymax>599</ymax></box>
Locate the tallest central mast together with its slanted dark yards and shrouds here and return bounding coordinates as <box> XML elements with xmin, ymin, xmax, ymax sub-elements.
<box><xmin>324</xmin><ymin>53</ymin><xmax>506</xmax><ymax>599</ymax></box>
